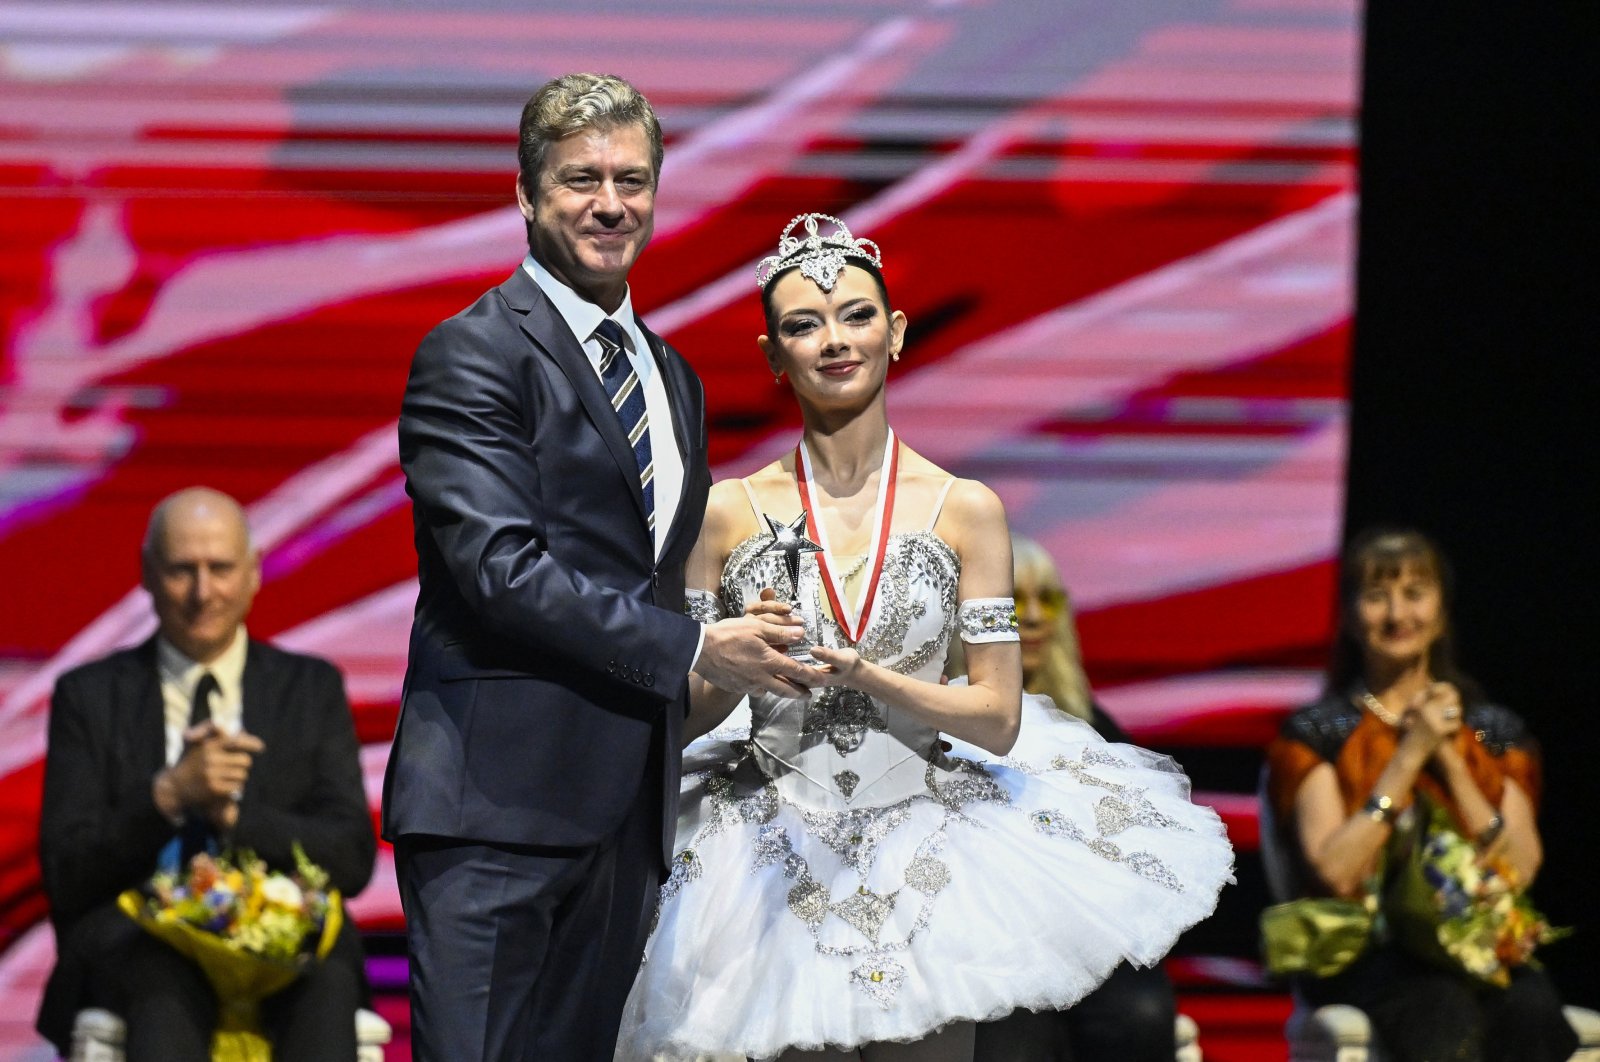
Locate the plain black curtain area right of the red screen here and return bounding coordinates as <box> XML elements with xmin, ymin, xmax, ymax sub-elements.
<box><xmin>1346</xmin><ymin>0</ymin><xmax>1600</xmax><ymax>1006</ymax></box>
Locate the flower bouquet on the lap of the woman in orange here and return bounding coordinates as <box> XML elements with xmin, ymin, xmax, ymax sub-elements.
<box><xmin>1386</xmin><ymin>808</ymin><xmax>1571</xmax><ymax>987</ymax></box>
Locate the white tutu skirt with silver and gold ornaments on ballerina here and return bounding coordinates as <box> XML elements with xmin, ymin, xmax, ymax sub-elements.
<box><xmin>618</xmin><ymin>697</ymin><xmax>1232</xmax><ymax>1059</ymax></box>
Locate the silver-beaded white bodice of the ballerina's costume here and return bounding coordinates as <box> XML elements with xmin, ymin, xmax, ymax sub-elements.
<box><xmin>722</xmin><ymin>531</ymin><xmax>960</xmax><ymax>809</ymax></box>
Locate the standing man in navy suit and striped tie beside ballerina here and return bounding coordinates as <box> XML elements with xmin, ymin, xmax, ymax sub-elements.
<box><xmin>384</xmin><ymin>74</ymin><xmax>816</xmax><ymax>1062</ymax></box>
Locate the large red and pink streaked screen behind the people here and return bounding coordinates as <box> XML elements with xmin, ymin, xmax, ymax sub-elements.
<box><xmin>0</xmin><ymin>0</ymin><xmax>1360</xmax><ymax>1049</ymax></box>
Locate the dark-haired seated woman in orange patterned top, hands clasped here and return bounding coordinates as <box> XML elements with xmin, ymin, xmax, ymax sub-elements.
<box><xmin>1267</xmin><ymin>531</ymin><xmax>1576</xmax><ymax>1062</ymax></box>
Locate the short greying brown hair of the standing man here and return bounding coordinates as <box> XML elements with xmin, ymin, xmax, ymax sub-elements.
<box><xmin>517</xmin><ymin>74</ymin><xmax>664</xmax><ymax>198</ymax></box>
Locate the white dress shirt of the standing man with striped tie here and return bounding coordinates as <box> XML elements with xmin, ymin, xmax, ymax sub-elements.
<box><xmin>522</xmin><ymin>254</ymin><xmax>683</xmax><ymax>557</ymax></box>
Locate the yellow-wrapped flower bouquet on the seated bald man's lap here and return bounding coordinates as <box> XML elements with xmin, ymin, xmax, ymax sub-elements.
<box><xmin>117</xmin><ymin>844</ymin><xmax>344</xmax><ymax>1062</ymax></box>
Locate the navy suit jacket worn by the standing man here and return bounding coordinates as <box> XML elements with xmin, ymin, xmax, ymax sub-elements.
<box><xmin>384</xmin><ymin>269</ymin><xmax>710</xmax><ymax>859</ymax></box>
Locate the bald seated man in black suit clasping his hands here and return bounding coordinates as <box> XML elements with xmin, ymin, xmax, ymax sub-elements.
<box><xmin>38</xmin><ymin>488</ymin><xmax>378</xmax><ymax>1062</ymax></box>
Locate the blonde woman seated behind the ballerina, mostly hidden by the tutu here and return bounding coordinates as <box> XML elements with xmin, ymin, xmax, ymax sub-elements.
<box><xmin>973</xmin><ymin>534</ymin><xmax>1178</xmax><ymax>1062</ymax></box>
